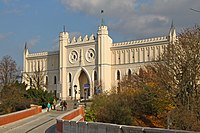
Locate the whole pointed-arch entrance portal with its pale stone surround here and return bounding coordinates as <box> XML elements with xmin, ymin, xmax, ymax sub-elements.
<box><xmin>72</xmin><ymin>68</ymin><xmax>92</xmax><ymax>99</ymax></box>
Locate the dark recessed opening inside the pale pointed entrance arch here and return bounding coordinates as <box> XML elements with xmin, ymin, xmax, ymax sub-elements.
<box><xmin>79</xmin><ymin>71</ymin><xmax>90</xmax><ymax>99</ymax></box>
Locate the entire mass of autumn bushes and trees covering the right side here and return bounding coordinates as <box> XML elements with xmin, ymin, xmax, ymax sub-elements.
<box><xmin>87</xmin><ymin>26</ymin><xmax>200</xmax><ymax>131</ymax></box>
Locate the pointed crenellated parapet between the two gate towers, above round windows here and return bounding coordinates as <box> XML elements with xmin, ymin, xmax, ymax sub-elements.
<box><xmin>69</xmin><ymin>34</ymin><xmax>95</xmax><ymax>44</ymax></box>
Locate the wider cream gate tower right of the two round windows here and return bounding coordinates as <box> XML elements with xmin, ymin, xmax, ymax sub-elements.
<box><xmin>97</xmin><ymin>24</ymin><xmax>112</xmax><ymax>91</ymax></box>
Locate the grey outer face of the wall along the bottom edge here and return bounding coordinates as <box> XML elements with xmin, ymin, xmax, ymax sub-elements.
<box><xmin>62</xmin><ymin>121</ymin><xmax>195</xmax><ymax>133</ymax></box>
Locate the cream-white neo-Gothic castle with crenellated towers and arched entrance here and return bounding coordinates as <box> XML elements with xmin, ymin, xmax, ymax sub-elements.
<box><xmin>23</xmin><ymin>24</ymin><xmax>176</xmax><ymax>99</ymax></box>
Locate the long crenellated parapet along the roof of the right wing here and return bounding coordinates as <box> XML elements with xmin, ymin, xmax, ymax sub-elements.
<box><xmin>112</xmin><ymin>36</ymin><xmax>168</xmax><ymax>47</ymax></box>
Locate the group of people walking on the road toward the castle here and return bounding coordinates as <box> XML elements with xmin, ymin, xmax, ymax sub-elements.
<box><xmin>47</xmin><ymin>99</ymin><xmax>67</xmax><ymax>112</ymax></box>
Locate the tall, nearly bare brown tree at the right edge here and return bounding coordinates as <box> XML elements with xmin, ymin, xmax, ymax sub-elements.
<box><xmin>152</xmin><ymin>26</ymin><xmax>200</xmax><ymax>130</ymax></box>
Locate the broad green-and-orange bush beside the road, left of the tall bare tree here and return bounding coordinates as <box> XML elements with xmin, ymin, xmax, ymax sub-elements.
<box><xmin>87</xmin><ymin>66</ymin><xmax>173</xmax><ymax>127</ymax></box>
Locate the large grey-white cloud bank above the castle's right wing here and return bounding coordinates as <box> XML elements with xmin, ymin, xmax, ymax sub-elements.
<box><xmin>60</xmin><ymin>0</ymin><xmax>200</xmax><ymax>38</ymax></box>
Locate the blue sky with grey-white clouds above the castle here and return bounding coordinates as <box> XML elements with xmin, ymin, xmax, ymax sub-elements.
<box><xmin>0</xmin><ymin>0</ymin><xmax>200</xmax><ymax>69</ymax></box>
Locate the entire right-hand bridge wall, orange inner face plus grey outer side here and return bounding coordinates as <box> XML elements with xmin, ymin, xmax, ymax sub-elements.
<box><xmin>56</xmin><ymin>106</ymin><xmax>195</xmax><ymax>133</ymax></box>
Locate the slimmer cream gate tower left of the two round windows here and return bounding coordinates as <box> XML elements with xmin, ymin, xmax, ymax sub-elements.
<box><xmin>58</xmin><ymin>30</ymin><xmax>69</xmax><ymax>99</ymax></box>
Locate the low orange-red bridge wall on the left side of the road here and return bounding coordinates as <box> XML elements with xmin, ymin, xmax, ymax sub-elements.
<box><xmin>0</xmin><ymin>106</ymin><xmax>42</xmax><ymax>126</ymax></box>
